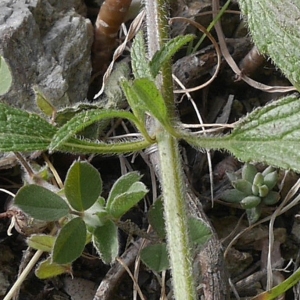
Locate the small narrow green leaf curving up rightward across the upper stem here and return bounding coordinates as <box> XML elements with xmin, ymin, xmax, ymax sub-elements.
<box><xmin>149</xmin><ymin>34</ymin><xmax>195</xmax><ymax>78</ymax></box>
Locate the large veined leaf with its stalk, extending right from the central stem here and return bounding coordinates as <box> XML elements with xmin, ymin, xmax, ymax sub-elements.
<box><xmin>184</xmin><ymin>95</ymin><xmax>300</xmax><ymax>172</ymax></box>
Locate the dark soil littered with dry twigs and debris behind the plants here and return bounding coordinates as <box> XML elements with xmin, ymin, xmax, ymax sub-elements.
<box><xmin>0</xmin><ymin>1</ymin><xmax>300</xmax><ymax>300</ymax></box>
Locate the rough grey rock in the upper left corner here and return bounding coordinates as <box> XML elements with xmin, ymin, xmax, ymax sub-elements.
<box><xmin>0</xmin><ymin>0</ymin><xmax>93</xmax><ymax>111</ymax></box>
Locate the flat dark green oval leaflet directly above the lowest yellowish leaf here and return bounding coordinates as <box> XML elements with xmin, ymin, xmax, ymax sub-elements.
<box><xmin>52</xmin><ymin>218</ymin><xmax>86</xmax><ymax>264</ymax></box>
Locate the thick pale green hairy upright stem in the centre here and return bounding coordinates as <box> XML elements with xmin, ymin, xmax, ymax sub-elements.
<box><xmin>145</xmin><ymin>0</ymin><xmax>196</xmax><ymax>300</ymax></box>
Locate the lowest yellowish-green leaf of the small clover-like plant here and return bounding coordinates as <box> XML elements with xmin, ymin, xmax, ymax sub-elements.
<box><xmin>35</xmin><ymin>258</ymin><xmax>72</xmax><ymax>279</ymax></box>
